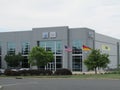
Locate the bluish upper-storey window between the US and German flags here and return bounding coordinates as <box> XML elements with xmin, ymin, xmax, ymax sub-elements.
<box><xmin>72</xmin><ymin>40</ymin><xmax>82</xmax><ymax>54</ymax></box>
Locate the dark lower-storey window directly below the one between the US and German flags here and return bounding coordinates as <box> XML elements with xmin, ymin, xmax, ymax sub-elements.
<box><xmin>72</xmin><ymin>56</ymin><xmax>82</xmax><ymax>71</ymax></box>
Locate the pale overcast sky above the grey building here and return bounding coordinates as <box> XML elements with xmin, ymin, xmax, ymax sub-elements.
<box><xmin>0</xmin><ymin>0</ymin><xmax>120</xmax><ymax>39</ymax></box>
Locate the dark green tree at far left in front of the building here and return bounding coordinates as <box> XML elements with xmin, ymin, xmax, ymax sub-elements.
<box><xmin>4</xmin><ymin>53</ymin><xmax>24</xmax><ymax>68</ymax></box>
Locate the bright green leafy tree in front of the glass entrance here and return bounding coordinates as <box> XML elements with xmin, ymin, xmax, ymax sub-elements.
<box><xmin>28</xmin><ymin>46</ymin><xmax>54</xmax><ymax>68</ymax></box>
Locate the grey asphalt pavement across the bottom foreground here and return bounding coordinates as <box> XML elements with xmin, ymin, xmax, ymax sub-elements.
<box><xmin>0</xmin><ymin>78</ymin><xmax>120</xmax><ymax>90</ymax></box>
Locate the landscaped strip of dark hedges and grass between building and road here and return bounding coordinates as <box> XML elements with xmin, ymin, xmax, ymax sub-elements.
<box><xmin>0</xmin><ymin>69</ymin><xmax>120</xmax><ymax>80</ymax></box>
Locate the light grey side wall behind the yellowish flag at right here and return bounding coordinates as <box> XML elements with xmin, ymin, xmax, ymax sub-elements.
<box><xmin>95</xmin><ymin>33</ymin><xmax>118</xmax><ymax>68</ymax></box>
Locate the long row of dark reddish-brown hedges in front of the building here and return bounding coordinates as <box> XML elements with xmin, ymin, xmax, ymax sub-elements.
<box><xmin>4</xmin><ymin>69</ymin><xmax>72</xmax><ymax>76</ymax></box>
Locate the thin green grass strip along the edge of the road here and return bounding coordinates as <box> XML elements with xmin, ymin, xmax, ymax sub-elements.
<box><xmin>0</xmin><ymin>74</ymin><xmax>120</xmax><ymax>80</ymax></box>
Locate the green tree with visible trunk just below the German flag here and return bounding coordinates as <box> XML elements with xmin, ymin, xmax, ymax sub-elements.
<box><xmin>84</xmin><ymin>49</ymin><xmax>110</xmax><ymax>74</ymax></box>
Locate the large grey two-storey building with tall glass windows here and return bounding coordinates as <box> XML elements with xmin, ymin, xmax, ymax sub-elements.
<box><xmin>0</xmin><ymin>26</ymin><xmax>120</xmax><ymax>72</ymax></box>
